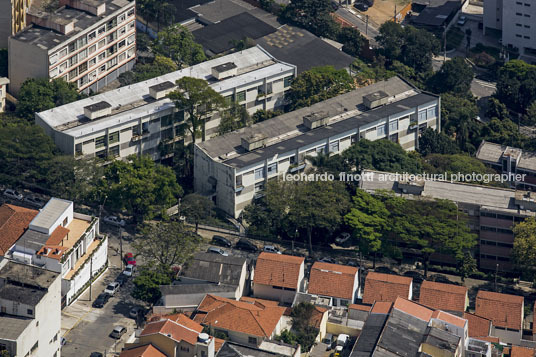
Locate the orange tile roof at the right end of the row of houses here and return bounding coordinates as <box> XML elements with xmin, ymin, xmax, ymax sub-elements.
<box><xmin>475</xmin><ymin>290</ymin><xmax>524</xmax><ymax>330</ymax></box>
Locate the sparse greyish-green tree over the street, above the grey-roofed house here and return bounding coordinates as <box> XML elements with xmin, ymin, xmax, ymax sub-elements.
<box><xmin>132</xmin><ymin>221</ymin><xmax>201</xmax><ymax>270</ymax></box>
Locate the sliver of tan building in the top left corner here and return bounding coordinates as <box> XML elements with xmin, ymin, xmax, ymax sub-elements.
<box><xmin>0</xmin><ymin>0</ymin><xmax>31</xmax><ymax>48</ymax></box>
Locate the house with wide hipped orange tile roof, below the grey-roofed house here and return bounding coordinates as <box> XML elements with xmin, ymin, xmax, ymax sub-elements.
<box><xmin>194</xmin><ymin>294</ymin><xmax>285</xmax><ymax>346</ymax></box>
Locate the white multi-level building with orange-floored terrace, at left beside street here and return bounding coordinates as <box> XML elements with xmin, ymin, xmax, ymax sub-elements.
<box><xmin>5</xmin><ymin>198</ymin><xmax>108</xmax><ymax>306</ymax></box>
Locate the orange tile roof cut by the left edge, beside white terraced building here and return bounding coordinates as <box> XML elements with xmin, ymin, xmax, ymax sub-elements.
<box><xmin>0</xmin><ymin>204</ymin><xmax>39</xmax><ymax>256</ymax></box>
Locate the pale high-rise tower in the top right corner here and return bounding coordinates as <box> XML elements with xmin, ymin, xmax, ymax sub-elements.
<box><xmin>484</xmin><ymin>0</ymin><xmax>536</xmax><ymax>62</ymax></box>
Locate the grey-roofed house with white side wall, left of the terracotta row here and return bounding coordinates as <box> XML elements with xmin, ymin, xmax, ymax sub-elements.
<box><xmin>154</xmin><ymin>253</ymin><xmax>248</xmax><ymax>313</ymax></box>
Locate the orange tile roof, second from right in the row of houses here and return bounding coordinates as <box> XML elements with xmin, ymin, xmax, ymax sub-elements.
<box><xmin>419</xmin><ymin>280</ymin><xmax>467</xmax><ymax>312</ymax></box>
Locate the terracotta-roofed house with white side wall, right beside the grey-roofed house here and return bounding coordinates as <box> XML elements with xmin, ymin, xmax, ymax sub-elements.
<box><xmin>253</xmin><ymin>252</ymin><xmax>305</xmax><ymax>303</ymax></box>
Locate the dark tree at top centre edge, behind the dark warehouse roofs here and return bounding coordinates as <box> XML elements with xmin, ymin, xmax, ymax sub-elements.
<box><xmin>281</xmin><ymin>0</ymin><xmax>339</xmax><ymax>39</ymax></box>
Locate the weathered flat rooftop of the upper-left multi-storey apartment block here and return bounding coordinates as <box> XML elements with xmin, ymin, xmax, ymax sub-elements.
<box><xmin>13</xmin><ymin>0</ymin><xmax>132</xmax><ymax>50</ymax></box>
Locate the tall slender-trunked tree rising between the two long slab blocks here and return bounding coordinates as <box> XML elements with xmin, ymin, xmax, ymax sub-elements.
<box><xmin>168</xmin><ymin>77</ymin><xmax>226</xmax><ymax>144</ymax></box>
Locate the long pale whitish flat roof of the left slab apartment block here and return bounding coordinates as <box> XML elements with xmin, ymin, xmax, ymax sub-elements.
<box><xmin>36</xmin><ymin>46</ymin><xmax>295</xmax><ymax>137</ymax></box>
